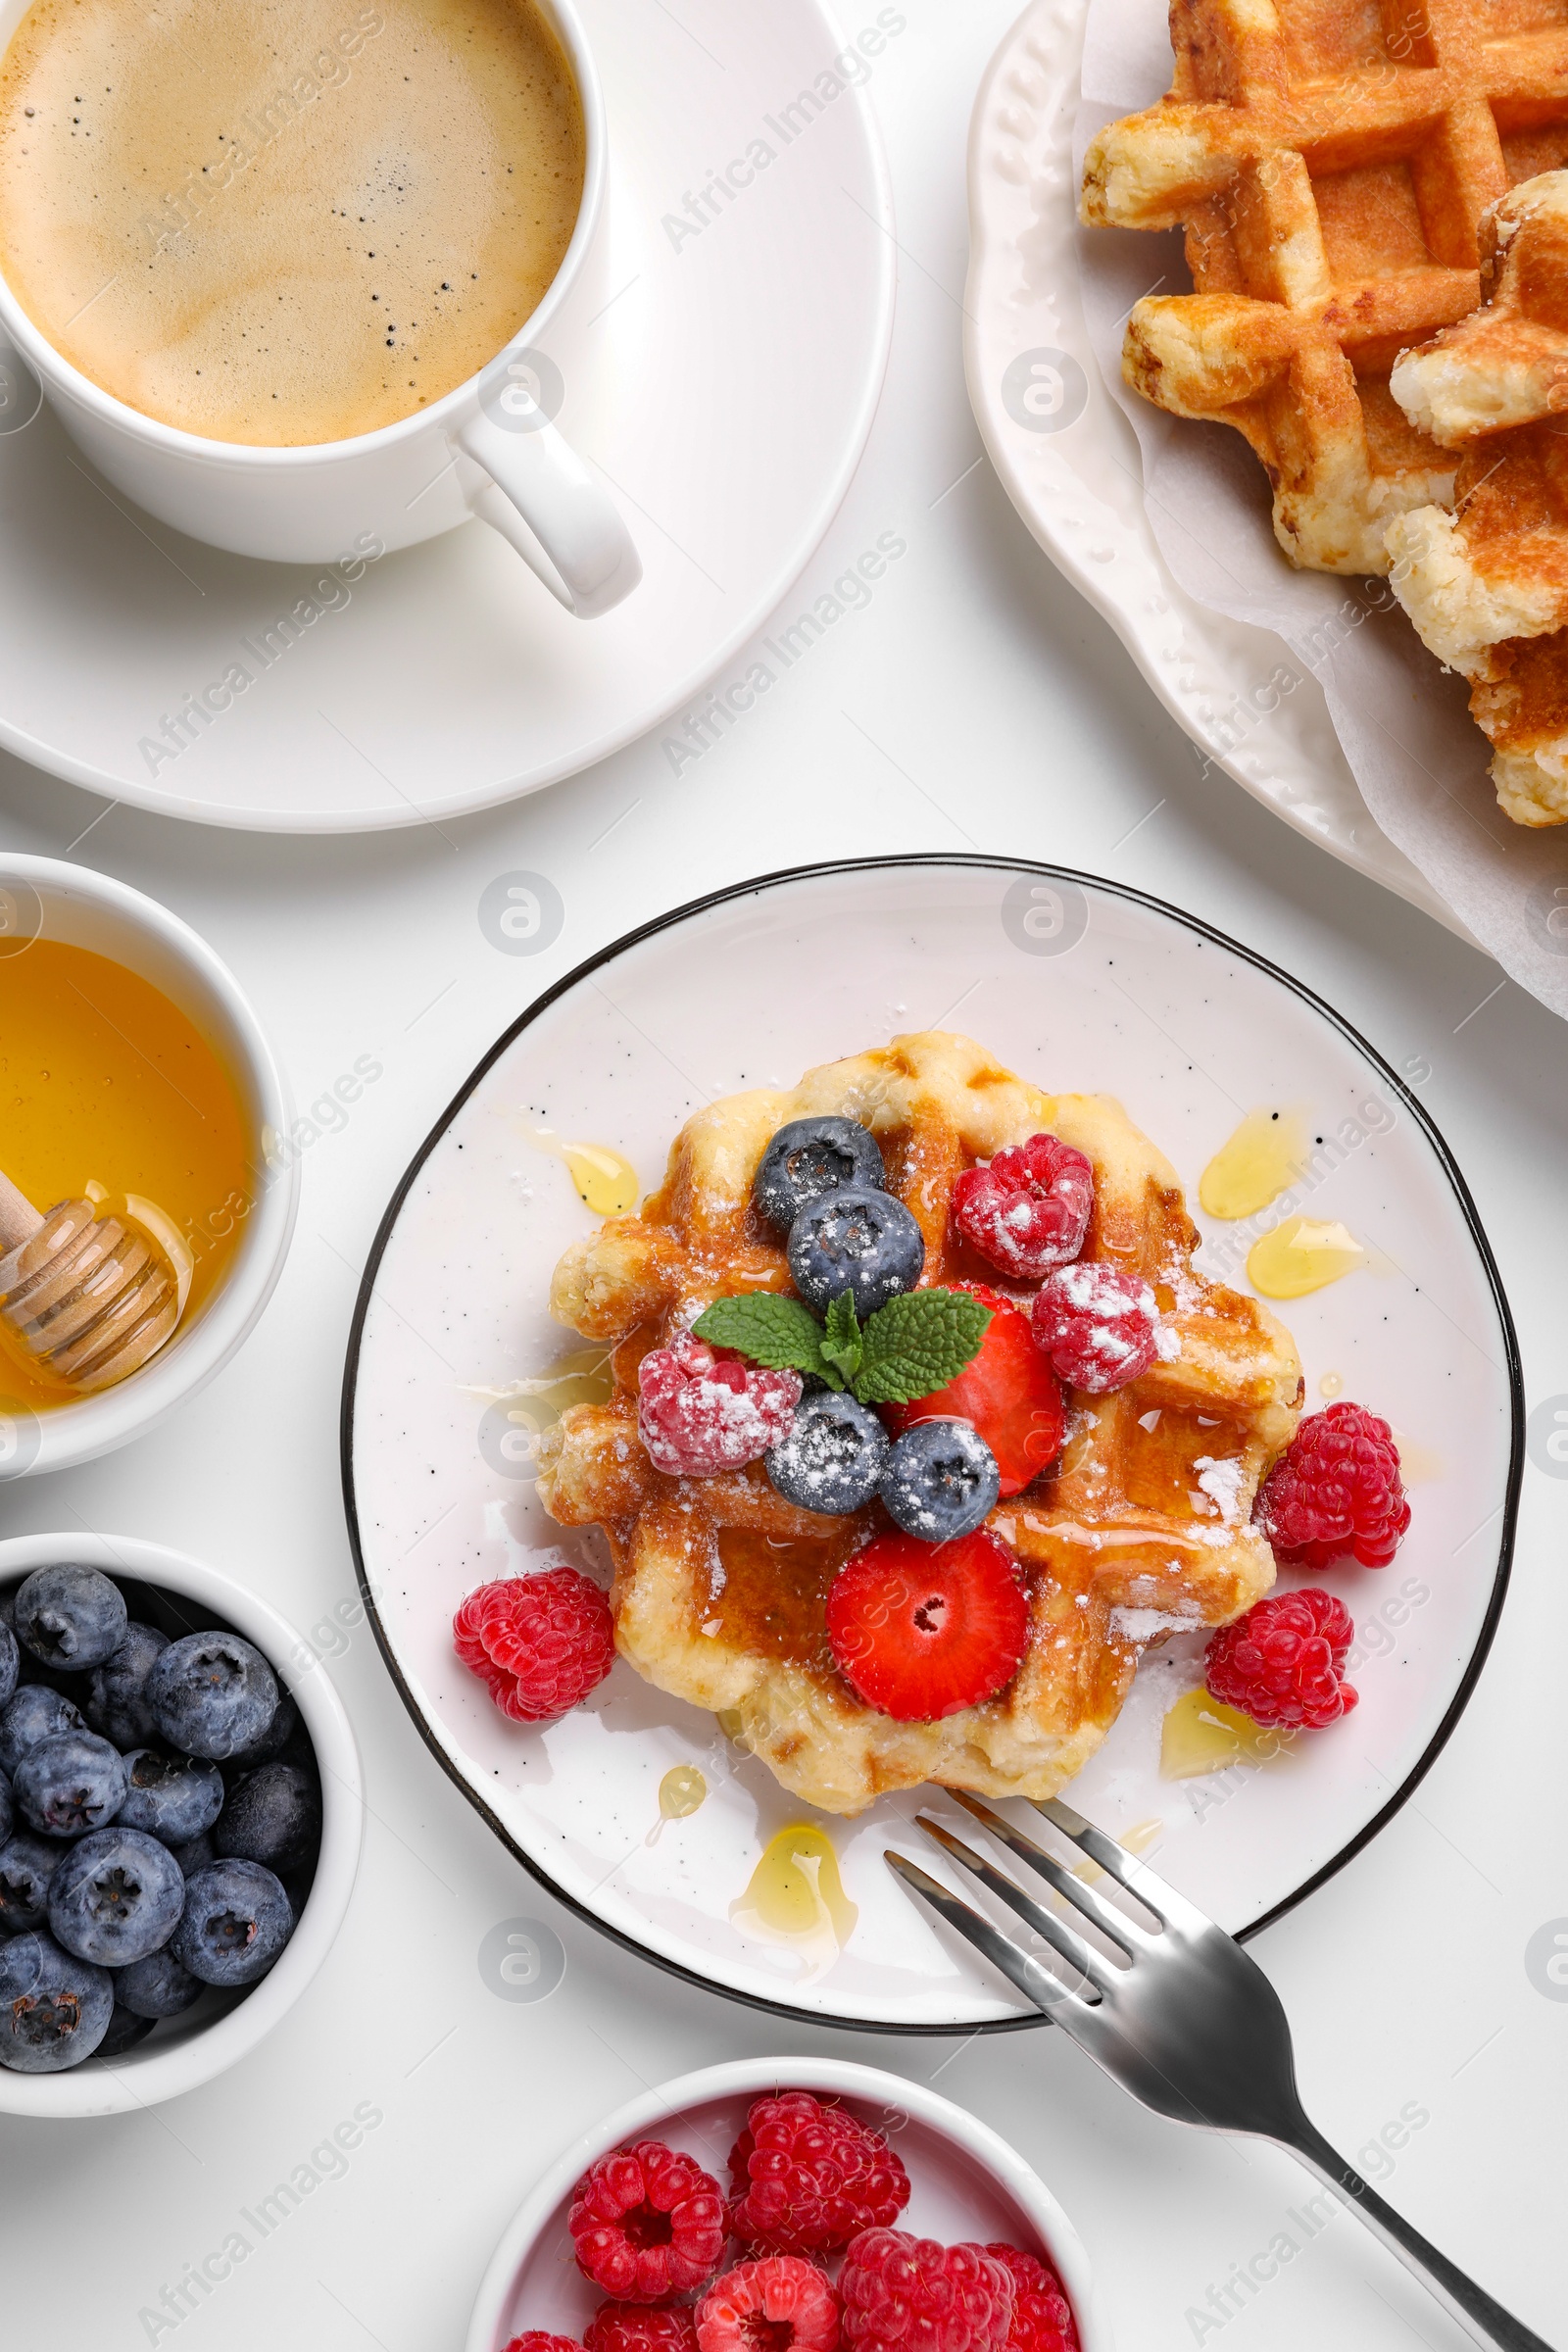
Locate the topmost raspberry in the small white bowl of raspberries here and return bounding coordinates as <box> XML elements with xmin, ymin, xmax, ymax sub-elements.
<box><xmin>728</xmin><ymin>2091</ymin><xmax>909</xmax><ymax>2258</ymax></box>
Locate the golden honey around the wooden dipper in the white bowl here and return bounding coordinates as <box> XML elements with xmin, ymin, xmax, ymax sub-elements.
<box><xmin>0</xmin><ymin>939</ymin><xmax>256</xmax><ymax>1411</ymax></box>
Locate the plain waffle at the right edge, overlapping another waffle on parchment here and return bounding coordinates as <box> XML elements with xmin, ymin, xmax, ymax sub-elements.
<box><xmin>1387</xmin><ymin>172</ymin><xmax>1568</xmax><ymax>825</ymax></box>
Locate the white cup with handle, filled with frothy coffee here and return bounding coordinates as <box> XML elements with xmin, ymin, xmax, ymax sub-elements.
<box><xmin>0</xmin><ymin>0</ymin><xmax>642</xmax><ymax>618</ymax></box>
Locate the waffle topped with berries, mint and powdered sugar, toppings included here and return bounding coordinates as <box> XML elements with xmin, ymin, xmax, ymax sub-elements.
<box><xmin>538</xmin><ymin>1033</ymin><xmax>1302</xmax><ymax>1813</ymax></box>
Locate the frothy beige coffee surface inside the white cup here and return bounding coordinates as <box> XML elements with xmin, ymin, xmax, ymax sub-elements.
<box><xmin>0</xmin><ymin>0</ymin><xmax>585</xmax><ymax>447</ymax></box>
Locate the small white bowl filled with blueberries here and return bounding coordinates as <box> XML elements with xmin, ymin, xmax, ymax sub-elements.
<box><xmin>0</xmin><ymin>1536</ymin><xmax>365</xmax><ymax>2117</ymax></box>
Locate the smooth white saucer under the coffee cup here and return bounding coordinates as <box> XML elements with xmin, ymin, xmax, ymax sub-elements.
<box><xmin>0</xmin><ymin>0</ymin><xmax>896</xmax><ymax>833</ymax></box>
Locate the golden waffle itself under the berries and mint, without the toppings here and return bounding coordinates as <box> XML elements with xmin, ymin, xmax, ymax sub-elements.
<box><xmin>538</xmin><ymin>1033</ymin><xmax>1302</xmax><ymax>1813</ymax></box>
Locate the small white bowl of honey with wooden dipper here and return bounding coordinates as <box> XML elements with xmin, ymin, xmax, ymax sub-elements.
<box><xmin>0</xmin><ymin>854</ymin><xmax>299</xmax><ymax>1480</ymax></box>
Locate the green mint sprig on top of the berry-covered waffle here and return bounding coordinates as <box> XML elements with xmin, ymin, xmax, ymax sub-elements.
<box><xmin>691</xmin><ymin>1289</ymin><xmax>992</xmax><ymax>1404</ymax></box>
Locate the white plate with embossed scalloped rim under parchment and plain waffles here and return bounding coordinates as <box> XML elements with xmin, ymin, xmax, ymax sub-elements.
<box><xmin>964</xmin><ymin>0</ymin><xmax>1469</xmax><ymax>939</ymax></box>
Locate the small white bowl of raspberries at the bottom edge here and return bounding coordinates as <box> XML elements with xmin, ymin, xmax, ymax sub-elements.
<box><xmin>466</xmin><ymin>2058</ymin><xmax>1112</xmax><ymax>2352</ymax></box>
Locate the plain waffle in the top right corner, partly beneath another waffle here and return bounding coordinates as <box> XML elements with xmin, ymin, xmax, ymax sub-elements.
<box><xmin>1079</xmin><ymin>0</ymin><xmax>1568</xmax><ymax>574</ymax></box>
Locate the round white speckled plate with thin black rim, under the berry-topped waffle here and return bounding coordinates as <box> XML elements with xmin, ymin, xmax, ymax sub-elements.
<box><xmin>343</xmin><ymin>858</ymin><xmax>1523</xmax><ymax>2033</ymax></box>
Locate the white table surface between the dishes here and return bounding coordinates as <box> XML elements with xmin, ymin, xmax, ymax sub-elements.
<box><xmin>0</xmin><ymin>0</ymin><xmax>1568</xmax><ymax>2352</ymax></box>
